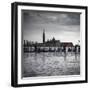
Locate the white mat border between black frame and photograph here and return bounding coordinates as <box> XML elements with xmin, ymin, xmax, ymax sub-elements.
<box><xmin>18</xmin><ymin>6</ymin><xmax>85</xmax><ymax>84</ymax></box>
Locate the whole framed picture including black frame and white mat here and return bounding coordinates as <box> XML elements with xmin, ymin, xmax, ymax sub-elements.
<box><xmin>11</xmin><ymin>2</ymin><xmax>87</xmax><ymax>87</ymax></box>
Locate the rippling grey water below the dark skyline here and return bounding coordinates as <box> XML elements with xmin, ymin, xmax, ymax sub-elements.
<box><xmin>22</xmin><ymin>52</ymin><xmax>80</xmax><ymax>77</ymax></box>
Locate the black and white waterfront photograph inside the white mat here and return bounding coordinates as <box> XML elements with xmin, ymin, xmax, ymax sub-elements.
<box><xmin>22</xmin><ymin>10</ymin><xmax>80</xmax><ymax>77</ymax></box>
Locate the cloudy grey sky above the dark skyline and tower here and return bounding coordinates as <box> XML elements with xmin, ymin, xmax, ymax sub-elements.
<box><xmin>22</xmin><ymin>10</ymin><xmax>80</xmax><ymax>44</ymax></box>
